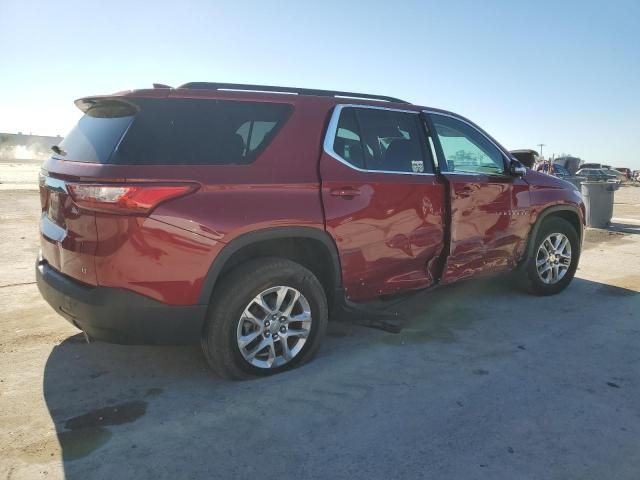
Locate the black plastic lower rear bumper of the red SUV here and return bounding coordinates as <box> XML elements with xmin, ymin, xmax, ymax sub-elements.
<box><xmin>36</xmin><ymin>262</ymin><xmax>207</xmax><ymax>345</ymax></box>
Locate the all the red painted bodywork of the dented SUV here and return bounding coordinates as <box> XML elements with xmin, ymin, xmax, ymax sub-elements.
<box><xmin>36</xmin><ymin>89</ymin><xmax>584</xmax><ymax>305</ymax></box>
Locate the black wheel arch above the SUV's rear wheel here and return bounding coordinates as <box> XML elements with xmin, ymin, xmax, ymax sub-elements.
<box><xmin>199</xmin><ymin>227</ymin><xmax>342</xmax><ymax>305</ymax></box>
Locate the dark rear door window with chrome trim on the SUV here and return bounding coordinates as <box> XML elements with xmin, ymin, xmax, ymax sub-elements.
<box><xmin>333</xmin><ymin>107</ymin><xmax>433</xmax><ymax>173</ymax></box>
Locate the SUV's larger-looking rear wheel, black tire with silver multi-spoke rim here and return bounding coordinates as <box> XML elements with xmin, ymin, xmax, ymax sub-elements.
<box><xmin>202</xmin><ymin>258</ymin><xmax>328</xmax><ymax>379</ymax></box>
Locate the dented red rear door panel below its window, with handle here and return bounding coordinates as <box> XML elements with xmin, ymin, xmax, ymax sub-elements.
<box><xmin>320</xmin><ymin>153</ymin><xmax>446</xmax><ymax>301</ymax></box>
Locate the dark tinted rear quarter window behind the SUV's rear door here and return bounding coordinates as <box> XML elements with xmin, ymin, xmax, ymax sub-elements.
<box><xmin>114</xmin><ymin>99</ymin><xmax>291</xmax><ymax>165</ymax></box>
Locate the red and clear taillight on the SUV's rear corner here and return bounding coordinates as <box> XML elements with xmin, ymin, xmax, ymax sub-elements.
<box><xmin>67</xmin><ymin>183</ymin><xmax>198</xmax><ymax>215</ymax></box>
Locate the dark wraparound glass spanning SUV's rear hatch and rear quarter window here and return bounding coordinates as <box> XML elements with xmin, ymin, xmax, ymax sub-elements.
<box><xmin>55</xmin><ymin>98</ymin><xmax>292</xmax><ymax>165</ymax></box>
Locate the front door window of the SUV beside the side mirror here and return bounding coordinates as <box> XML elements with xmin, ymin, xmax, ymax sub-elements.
<box><xmin>431</xmin><ymin>114</ymin><xmax>505</xmax><ymax>175</ymax></box>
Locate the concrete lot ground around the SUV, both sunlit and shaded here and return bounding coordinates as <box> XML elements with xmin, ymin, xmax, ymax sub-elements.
<box><xmin>0</xmin><ymin>177</ymin><xmax>640</xmax><ymax>480</ymax></box>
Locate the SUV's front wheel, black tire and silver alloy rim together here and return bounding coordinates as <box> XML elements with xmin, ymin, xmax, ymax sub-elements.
<box><xmin>518</xmin><ymin>217</ymin><xmax>580</xmax><ymax>295</ymax></box>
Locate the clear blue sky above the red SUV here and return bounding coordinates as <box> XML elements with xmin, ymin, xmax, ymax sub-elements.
<box><xmin>0</xmin><ymin>0</ymin><xmax>640</xmax><ymax>168</ymax></box>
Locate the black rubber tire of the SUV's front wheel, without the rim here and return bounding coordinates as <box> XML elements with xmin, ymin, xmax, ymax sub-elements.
<box><xmin>517</xmin><ymin>217</ymin><xmax>580</xmax><ymax>295</ymax></box>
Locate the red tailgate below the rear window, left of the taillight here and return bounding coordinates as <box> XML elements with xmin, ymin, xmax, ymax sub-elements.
<box><xmin>40</xmin><ymin>173</ymin><xmax>97</xmax><ymax>285</ymax></box>
